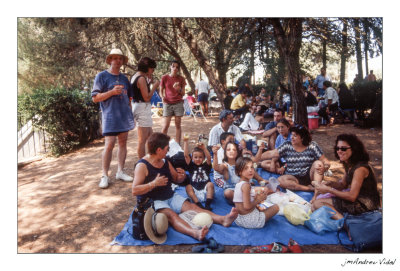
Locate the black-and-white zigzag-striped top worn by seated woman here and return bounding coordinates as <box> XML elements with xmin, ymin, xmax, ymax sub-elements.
<box><xmin>278</xmin><ymin>141</ymin><xmax>323</xmax><ymax>176</ymax></box>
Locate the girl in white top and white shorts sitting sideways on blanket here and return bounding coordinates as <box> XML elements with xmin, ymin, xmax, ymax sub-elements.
<box><xmin>233</xmin><ymin>157</ymin><xmax>279</xmax><ymax>229</ymax></box>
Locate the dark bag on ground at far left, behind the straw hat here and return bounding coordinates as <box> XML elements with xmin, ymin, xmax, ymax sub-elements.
<box><xmin>131</xmin><ymin>198</ymin><xmax>153</xmax><ymax>240</ymax></box>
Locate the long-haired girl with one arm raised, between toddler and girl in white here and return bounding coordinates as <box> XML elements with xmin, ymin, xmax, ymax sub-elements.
<box><xmin>213</xmin><ymin>142</ymin><xmax>268</xmax><ymax>204</ymax></box>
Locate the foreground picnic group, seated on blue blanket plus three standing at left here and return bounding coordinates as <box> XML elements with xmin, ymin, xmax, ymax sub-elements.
<box><xmin>92</xmin><ymin>49</ymin><xmax>380</xmax><ymax>240</ymax></box>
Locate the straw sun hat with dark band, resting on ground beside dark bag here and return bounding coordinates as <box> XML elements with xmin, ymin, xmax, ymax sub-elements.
<box><xmin>143</xmin><ymin>208</ymin><xmax>168</xmax><ymax>244</ymax></box>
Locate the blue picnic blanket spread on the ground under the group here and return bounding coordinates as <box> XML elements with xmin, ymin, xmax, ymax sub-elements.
<box><xmin>111</xmin><ymin>169</ymin><xmax>352</xmax><ymax>246</ymax></box>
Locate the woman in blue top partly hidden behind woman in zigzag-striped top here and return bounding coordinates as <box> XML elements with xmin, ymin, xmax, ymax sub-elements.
<box><xmin>260</xmin><ymin>119</ymin><xmax>292</xmax><ymax>175</ymax></box>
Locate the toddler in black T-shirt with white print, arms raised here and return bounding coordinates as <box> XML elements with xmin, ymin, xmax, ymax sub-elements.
<box><xmin>183</xmin><ymin>136</ymin><xmax>214</xmax><ymax>211</ymax></box>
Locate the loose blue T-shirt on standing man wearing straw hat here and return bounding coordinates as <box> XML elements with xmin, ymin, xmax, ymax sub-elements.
<box><xmin>92</xmin><ymin>71</ymin><xmax>135</xmax><ymax>134</ymax></box>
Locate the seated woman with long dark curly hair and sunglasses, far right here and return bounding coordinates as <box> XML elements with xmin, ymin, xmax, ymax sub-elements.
<box><xmin>312</xmin><ymin>134</ymin><xmax>380</xmax><ymax>219</ymax></box>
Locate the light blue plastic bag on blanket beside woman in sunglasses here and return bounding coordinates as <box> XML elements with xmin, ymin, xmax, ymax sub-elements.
<box><xmin>304</xmin><ymin>206</ymin><xmax>344</xmax><ymax>234</ymax></box>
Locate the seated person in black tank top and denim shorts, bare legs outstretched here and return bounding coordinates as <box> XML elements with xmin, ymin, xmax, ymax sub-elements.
<box><xmin>132</xmin><ymin>133</ymin><xmax>238</xmax><ymax>240</ymax></box>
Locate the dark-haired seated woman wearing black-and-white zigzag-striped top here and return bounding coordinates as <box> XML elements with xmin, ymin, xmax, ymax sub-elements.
<box><xmin>261</xmin><ymin>125</ymin><xmax>330</xmax><ymax>191</ymax></box>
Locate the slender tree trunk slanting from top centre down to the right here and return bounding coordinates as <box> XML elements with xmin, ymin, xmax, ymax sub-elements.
<box><xmin>172</xmin><ymin>18</ymin><xmax>226</xmax><ymax>108</ymax></box>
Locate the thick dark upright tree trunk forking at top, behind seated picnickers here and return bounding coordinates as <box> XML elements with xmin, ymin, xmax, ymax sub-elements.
<box><xmin>271</xmin><ymin>18</ymin><xmax>308</xmax><ymax>127</ymax></box>
